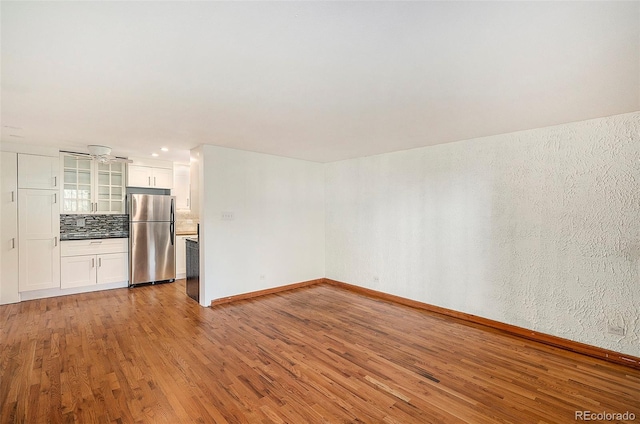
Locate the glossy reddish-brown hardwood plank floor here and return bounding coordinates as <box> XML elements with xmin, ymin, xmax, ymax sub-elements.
<box><xmin>0</xmin><ymin>280</ymin><xmax>640</xmax><ymax>424</ymax></box>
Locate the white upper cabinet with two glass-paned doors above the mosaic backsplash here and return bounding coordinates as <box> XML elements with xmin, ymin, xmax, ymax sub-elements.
<box><xmin>60</xmin><ymin>153</ymin><xmax>125</xmax><ymax>214</ymax></box>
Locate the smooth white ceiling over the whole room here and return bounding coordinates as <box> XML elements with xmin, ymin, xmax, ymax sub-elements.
<box><xmin>0</xmin><ymin>1</ymin><xmax>640</xmax><ymax>162</ymax></box>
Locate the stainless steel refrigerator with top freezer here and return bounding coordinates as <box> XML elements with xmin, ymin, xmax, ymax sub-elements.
<box><xmin>127</xmin><ymin>194</ymin><xmax>176</xmax><ymax>286</ymax></box>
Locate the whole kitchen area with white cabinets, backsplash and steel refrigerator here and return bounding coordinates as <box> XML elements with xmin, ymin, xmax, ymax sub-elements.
<box><xmin>0</xmin><ymin>146</ymin><xmax>199</xmax><ymax>304</ymax></box>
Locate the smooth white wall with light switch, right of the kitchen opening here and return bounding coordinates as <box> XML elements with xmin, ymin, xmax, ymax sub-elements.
<box><xmin>198</xmin><ymin>145</ymin><xmax>325</xmax><ymax>305</ymax></box>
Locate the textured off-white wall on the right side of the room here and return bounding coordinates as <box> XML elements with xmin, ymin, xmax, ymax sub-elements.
<box><xmin>325</xmin><ymin>113</ymin><xmax>640</xmax><ymax>356</ymax></box>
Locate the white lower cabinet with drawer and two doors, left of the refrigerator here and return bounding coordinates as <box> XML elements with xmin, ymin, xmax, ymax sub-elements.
<box><xmin>60</xmin><ymin>239</ymin><xmax>129</xmax><ymax>289</ymax></box>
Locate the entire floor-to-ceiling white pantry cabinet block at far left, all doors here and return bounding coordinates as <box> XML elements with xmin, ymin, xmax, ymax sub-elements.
<box><xmin>0</xmin><ymin>152</ymin><xmax>60</xmax><ymax>303</ymax></box>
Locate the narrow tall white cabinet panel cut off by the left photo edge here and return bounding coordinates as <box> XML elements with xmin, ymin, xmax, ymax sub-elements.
<box><xmin>0</xmin><ymin>152</ymin><xmax>20</xmax><ymax>305</ymax></box>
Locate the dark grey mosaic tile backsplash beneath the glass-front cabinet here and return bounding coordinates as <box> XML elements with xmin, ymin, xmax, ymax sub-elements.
<box><xmin>60</xmin><ymin>214</ymin><xmax>129</xmax><ymax>240</ymax></box>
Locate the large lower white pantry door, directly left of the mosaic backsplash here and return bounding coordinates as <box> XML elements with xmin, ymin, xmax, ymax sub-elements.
<box><xmin>18</xmin><ymin>189</ymin><xmax>60</xmax><ymax>292</ymax></box>
